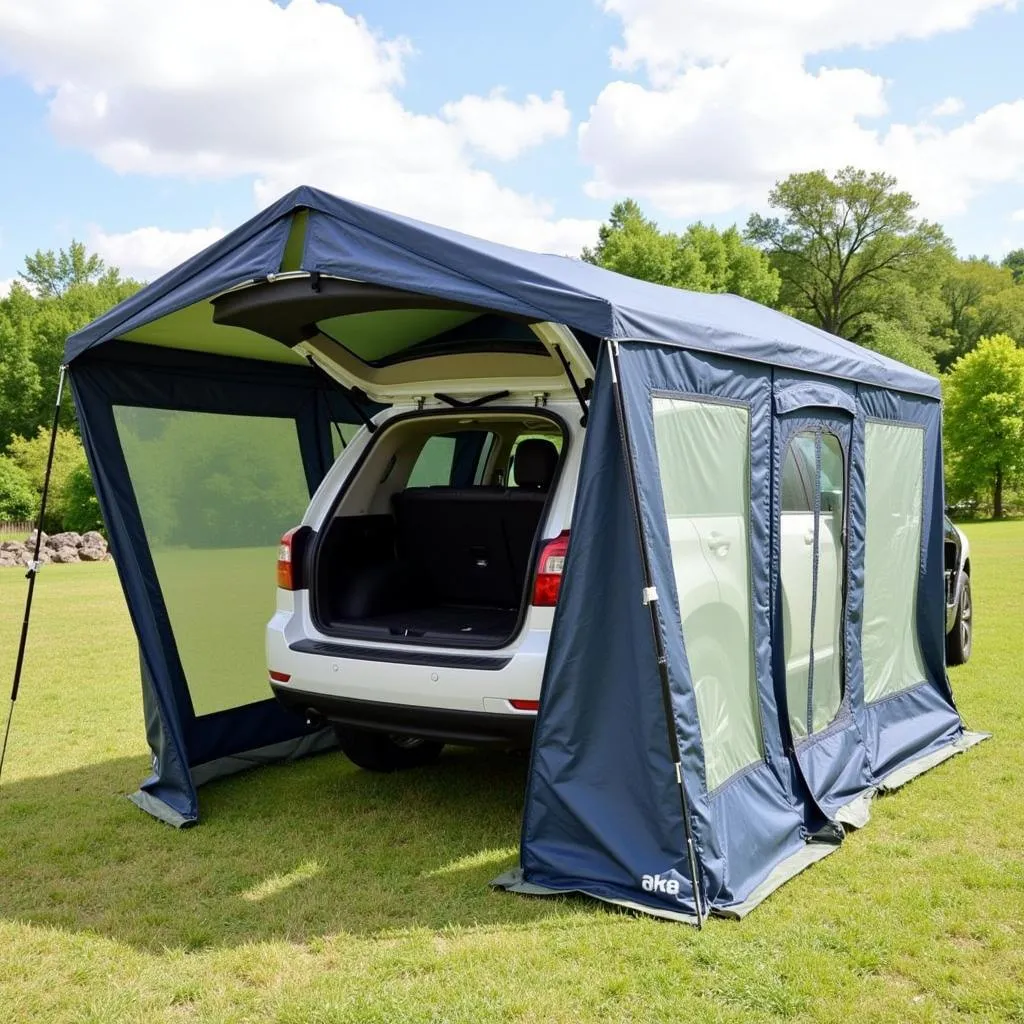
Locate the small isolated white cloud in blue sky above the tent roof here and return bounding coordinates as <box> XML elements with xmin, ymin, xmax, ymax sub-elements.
<box><xmin>441</xmin><ymin>88</ymin><xmax>572</xmax><ymax>160</ymax></box>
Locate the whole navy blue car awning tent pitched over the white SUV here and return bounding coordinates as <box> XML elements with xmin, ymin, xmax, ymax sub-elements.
<box><xmin>66</xmin><ymin>187</ymin><xmax>978</xmax><ymax>921</ymax></box>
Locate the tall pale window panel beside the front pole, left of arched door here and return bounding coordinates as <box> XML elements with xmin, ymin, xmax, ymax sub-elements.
<box><xmin>653</xmin><ymin>397</ymin><xmax>763</xmax><ymax>790</ymax></box>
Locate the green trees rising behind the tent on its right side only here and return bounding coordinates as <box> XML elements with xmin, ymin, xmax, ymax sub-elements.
<box><xmin>583</xmin><ymin>168</ymin><xmax>1024</xmax><ymax>517</ymax></box>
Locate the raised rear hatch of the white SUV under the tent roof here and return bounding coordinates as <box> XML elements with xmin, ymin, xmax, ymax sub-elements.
<box><xmin>214</xmin><ymin>273</ymin><xmax>597</xmax><ymax>406</ymax></box>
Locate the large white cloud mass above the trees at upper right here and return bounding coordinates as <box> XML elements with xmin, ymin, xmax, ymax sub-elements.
<box><xmin>580</xmin><ymin>0</ymin><xmax>1024</xmax><ymax>217</ymax></box>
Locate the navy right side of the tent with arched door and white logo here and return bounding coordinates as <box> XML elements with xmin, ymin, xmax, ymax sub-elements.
<box><xmin>513</xmin><ymin>342</ymin><xmax>964</xmax><ymax>915</ymax></box>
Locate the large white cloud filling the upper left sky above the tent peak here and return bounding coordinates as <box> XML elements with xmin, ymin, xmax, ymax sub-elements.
<box><xmin>0</xmin><ymin>0</ymin><xmax>596</xmax><ymax>252</ymax></box>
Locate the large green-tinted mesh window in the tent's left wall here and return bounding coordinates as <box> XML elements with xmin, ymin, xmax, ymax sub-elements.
<box><xmin>114</xmin><ymin>406</ymin><xmax>309</xmax><ymax>715</ymax></box>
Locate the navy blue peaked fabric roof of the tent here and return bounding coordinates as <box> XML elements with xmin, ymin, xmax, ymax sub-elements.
<box><xmin>65</xmin><ymin>186</ymin><xmax>940</xmax><ymax>398</ymax></box>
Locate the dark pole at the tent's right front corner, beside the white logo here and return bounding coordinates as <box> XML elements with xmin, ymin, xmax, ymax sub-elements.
<box><xmin>606</xmin><ymin>338</ymin><xmax>706</xmax><ymax>929</ymax></box>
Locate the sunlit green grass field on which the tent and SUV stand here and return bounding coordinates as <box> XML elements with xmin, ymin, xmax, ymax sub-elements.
<box><xmin>0</xmin><ymin>522</ymin><xmax>1024</xmax><ymax>1024</ymax></box>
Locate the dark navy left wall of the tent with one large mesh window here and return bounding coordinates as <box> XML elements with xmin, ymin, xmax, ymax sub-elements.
<box><xmin>71</xmin><ymin>343</ymin><xmax>376</xmax><ymax>824</ymax></box>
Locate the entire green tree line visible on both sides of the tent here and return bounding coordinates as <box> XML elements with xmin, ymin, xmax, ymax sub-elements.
<box><xmin>0</xmin><ymin>168</ymin><xmax>1024</xmax><ymax>543</ymax></box>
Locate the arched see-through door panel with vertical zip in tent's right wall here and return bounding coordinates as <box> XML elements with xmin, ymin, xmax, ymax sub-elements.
<box><xmin>778</xmin><ymin>416</ymin><xmax>850</xmax><ymax>749</ymax></box>
